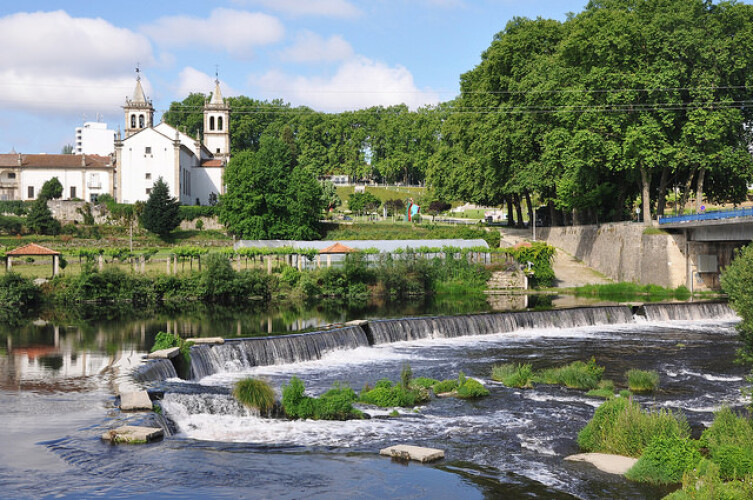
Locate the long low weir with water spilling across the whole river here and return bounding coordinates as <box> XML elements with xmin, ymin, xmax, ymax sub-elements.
<box><xmin>135</xmin><ymin>302</ymin><xmax>736</xmax><ymax>382</ymax></box>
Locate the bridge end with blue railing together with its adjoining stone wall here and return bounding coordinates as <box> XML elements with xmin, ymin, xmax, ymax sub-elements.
<box><xmin>539</xmin><ymin>208</ymin><xmax>753</xmax><ymax>291</ymax></box>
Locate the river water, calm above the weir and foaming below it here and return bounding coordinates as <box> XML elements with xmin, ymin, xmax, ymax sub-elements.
<box><xmin>0</xmin><ymin>298</ymin><xmax>746</xmax><ymax>498</ymax></box>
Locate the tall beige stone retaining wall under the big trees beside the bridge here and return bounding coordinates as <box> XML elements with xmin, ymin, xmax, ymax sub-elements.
<box><xmin>538</xmin><ymin>223</ymin><xmax>688</xmax><ymax>288</ymax></box>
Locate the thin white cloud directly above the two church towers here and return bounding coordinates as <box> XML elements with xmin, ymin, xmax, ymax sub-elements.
<box><xmin>142</xmin><ymin>8</ymin><xmax>285</xmax><ymax>58</ymax></box>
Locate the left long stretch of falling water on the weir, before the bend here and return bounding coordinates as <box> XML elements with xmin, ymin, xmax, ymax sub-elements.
<box><xmin>191</xmin><ymin>326</ymin><xmax>369</xmax><ymax>379</ymax></box>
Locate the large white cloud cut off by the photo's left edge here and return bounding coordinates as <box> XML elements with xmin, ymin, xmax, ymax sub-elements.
<box><xmin>0</xmin><ymin>11</ymin><xmax>154</xmax><ymax>113</ymax></box>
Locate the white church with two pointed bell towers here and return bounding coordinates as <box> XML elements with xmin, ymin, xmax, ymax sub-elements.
<box><xmin>115</xmin><ymin>73</ymin><xmax>230</xmax><ymax>205</ymax></box>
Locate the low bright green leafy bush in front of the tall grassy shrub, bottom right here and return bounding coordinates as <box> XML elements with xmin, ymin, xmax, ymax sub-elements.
<box><xmin>625</xmin><ymin>434</ymin><xmax>701</xmax><ymax>484</ymax></box>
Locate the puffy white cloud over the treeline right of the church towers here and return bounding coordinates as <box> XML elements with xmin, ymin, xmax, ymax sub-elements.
<box><xmin>251</xmin><ymin>57</ymin><xmax>439</xmax><ymax>112</ymax></box>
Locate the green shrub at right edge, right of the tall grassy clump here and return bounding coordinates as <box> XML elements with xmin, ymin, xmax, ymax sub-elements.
<box><xmin>701</xmin><ymin>407</ymin><xmax>753</xmax><ymax>479</ymax></box>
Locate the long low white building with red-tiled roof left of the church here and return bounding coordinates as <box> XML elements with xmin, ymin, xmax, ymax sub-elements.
<box><xmin>0</xmin><ymin>153</ymin><xmax>115</xmax><ymax>201</ymax></box>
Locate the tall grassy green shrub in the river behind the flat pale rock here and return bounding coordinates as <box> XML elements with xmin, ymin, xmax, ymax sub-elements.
<box><xmin>578</xmin><ymin>398</ymin><xmax>690</xmax><ymax>457</ymax></box>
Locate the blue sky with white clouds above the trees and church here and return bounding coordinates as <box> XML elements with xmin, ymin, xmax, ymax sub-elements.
<box><xmin>0</xmin><ymin>0</ymin><xmax>587</xmax><ymax>153</ymax></box>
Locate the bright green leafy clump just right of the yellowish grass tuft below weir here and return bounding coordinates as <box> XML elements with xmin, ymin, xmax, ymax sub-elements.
<box><xmin>282</xmin><ymin>377</ymin><xmax>363</xmax><ymax>420</ymax></box>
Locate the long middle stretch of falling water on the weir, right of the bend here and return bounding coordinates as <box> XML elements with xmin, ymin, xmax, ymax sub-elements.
<box><xmin>369</xmin><ymin>306</ymin><xmax>633</xmax><ymax>344</ymax></box>
